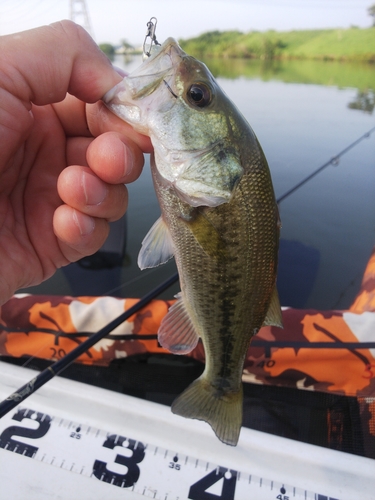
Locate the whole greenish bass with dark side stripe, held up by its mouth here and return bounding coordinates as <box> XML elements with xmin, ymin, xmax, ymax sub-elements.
<box><xmin>103</xmin><ymin>38</ymin><xmax>282</xmax><ymax>446</ymax></box>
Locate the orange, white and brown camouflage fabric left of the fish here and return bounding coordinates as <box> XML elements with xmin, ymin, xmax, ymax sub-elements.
<box><xmin>0</xmin><ymin>294</ymin><xmax>173</xmax><ymax>366</ymax></box>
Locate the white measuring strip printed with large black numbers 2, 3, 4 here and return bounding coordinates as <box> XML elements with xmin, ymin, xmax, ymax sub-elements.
<box><xmin>0</xmin><ymin>408</ymin><xmax>337</xmax><ymax>500</ymax></box>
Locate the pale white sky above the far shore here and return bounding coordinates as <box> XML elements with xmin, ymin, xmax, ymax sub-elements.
<box><xmin>0</xmin><ymin>0</ymin><xmax>375</xmax><ymax>45</ymax></box>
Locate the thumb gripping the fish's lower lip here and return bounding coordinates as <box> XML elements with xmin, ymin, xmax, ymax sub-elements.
<box><xmin>0</xmin><ymin>21</ymin><xmax>121</xmax><ymax>105</ymax></box>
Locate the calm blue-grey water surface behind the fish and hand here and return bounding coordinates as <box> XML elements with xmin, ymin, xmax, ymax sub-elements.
<box><xmin>26</xmin><ymin>57</ymin><xmax>375</xmax><ymax>309</ymax></box>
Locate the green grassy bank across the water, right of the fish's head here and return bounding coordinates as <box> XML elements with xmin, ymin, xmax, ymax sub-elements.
<box><xmin>180</xmin><ymin>28</ymin><xmax>375</xmax><ymax>62</ymax></box>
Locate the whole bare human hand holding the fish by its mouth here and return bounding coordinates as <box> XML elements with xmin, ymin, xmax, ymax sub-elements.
<box><xmin>0</xmin><ymin>21</ymin><xmax>151</xmax><ymax>305</ymax></box>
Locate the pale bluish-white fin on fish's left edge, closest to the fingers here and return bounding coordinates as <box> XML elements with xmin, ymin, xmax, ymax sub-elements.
<box><xmin>138</xmin><ymin>217</ymin><xmax>174</xmax><ymax>269</ymax></box>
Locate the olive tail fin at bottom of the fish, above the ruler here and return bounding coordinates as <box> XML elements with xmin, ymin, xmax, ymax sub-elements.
<box><xmin>172</xmin><ymin>376</ymin><xmax>243</xmax><ymax>446</ymax></box>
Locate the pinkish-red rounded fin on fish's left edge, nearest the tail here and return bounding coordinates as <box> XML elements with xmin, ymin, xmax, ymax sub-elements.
<box><xmin>158</xmin><ymin>293</ymin><xmax>199</xmax><ymax>354</ymax></box>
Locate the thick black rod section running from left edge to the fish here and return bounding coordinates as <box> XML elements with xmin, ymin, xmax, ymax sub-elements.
<box><xmin>0</xmin><ymin>273</ymin><xmax>178</xmax><ymax>418</ymax></box>
